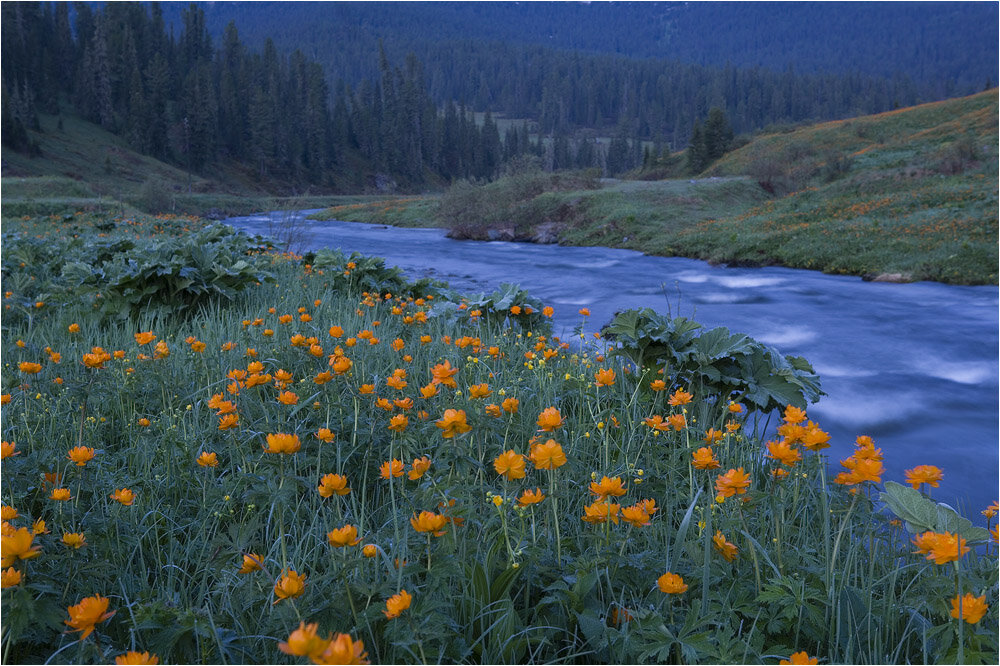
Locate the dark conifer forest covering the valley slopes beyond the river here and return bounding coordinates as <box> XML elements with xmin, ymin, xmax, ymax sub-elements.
<box><xmin>2</xmin><ymin>2</ymin><xmax>995</xmax><ymax>189</ymax></box>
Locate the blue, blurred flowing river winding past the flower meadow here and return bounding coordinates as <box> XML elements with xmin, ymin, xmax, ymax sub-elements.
<box><xmin>225</xmin><ymin>211</ymin><xmax>1000</xmax><ymax>510</ymax></box>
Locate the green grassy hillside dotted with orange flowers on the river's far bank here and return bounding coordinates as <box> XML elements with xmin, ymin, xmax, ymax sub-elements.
<box><xmin>325</xmin><ymin>89</ymin><xmax>998</xmax><ymax>284</ymax></box>
